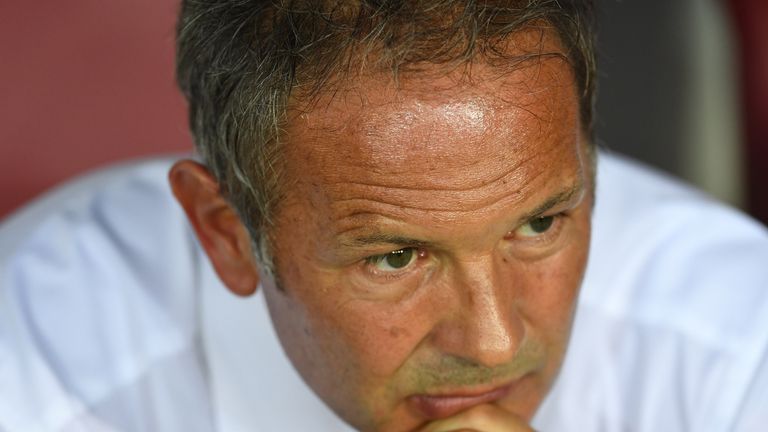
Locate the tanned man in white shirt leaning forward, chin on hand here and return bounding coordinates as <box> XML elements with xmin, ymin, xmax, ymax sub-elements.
<box><xmin>0</xmin><ymin>1</ymin><xmax>768</xmax><ymax>432</ymax></box>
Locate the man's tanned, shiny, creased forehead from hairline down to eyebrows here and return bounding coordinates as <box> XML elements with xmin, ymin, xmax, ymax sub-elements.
<box><xmin>276</xmin><ymin>29</ymin><xmax>583</xmax><ymax>240</ymax></box>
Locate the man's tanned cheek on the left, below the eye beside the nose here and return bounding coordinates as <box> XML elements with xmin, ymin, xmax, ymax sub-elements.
<box><xmin>276</xmin><ymin>248</ymin><xmax>436</xmax><ymax>391</ymax></box>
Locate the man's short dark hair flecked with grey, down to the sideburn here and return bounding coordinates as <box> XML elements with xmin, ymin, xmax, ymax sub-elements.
<box><xmin>176</xmin><ymin>0</ymin><xmax>595</xmax><ymax>271</ymax></box>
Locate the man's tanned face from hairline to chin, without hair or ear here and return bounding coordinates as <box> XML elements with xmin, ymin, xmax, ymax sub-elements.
<box><xmin>264</xmin><ymin>34</ymin><xmax>592</xmax><ymax>431</ymax></box>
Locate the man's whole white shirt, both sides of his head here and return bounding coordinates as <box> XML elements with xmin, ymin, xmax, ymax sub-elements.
<box><xmin>0</xmin><ymin>154</ymin><xmax>768</xmax><ymax>432</ymax></box>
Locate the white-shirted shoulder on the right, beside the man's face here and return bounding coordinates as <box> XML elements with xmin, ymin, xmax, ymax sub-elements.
<box><xmin>540</xmin><ymin>154</ymin><xmax>768</xmax><ymax>431</ymax></box>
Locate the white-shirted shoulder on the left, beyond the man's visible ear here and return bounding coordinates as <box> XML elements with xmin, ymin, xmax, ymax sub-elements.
<box><xmin>0</xmin><ymin>158</ymin><xmax>213</xmax><ymax>430</ymax></box>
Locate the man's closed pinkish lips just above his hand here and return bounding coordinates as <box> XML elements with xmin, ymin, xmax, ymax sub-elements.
<box><xmin>408</xmin><ymin>381</ymin><xmax>516</xmax><ymax>420</ymax></box>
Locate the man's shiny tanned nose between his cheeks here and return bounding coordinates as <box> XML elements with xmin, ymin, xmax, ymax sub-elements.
<box><xmin>432</xmin><ymin>257</ymin><xmax>525</xmax><ymax>367</ymax></box>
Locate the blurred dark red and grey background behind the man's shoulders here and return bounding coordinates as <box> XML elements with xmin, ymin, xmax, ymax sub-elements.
<box><xmin>0</xmin><ymin>0</ymin><xmax>768</xmax><ymax>223</ymax></box>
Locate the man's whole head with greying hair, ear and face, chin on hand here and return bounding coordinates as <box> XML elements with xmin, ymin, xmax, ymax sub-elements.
<box><xmin>170</xmin><ymin>2</ymin><xmax>594</xmax><ymax>431</ymax></box>
